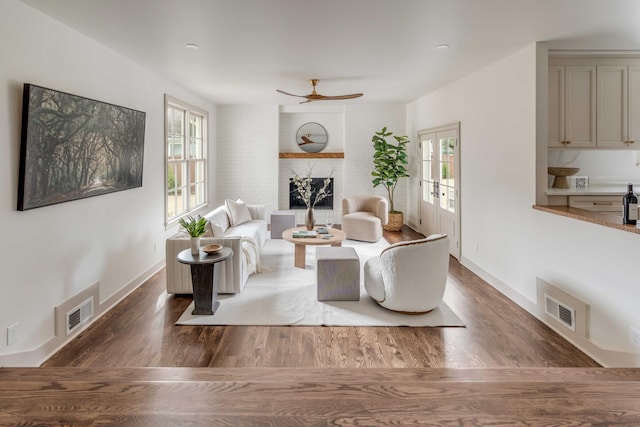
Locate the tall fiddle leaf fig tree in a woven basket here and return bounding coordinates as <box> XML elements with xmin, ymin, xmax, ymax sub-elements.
<box><xmin>371</xmin><ymin>127</ymin><xmax>409</xmax><ymax>231</ymax></box>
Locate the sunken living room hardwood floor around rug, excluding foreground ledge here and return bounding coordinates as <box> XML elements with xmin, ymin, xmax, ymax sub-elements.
<box><xmin>43</xmin><ymin>227</ymin><xmax>599</xmax><ymax>368</ymax></box>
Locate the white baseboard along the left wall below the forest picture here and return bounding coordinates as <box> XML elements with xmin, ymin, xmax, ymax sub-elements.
<box><xmin>0</xmin><ymin>259</ymin><xmax>165</xmax><ymax>367</ymax></box>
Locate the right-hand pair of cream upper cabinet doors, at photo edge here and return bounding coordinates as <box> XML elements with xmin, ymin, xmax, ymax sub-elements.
<box><xmin>596</xmin><ymin>65</ymin><xmax>640</xmax><ymax>149</ymax></box>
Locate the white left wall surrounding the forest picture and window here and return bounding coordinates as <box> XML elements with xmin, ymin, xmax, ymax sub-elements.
<box><xmin>0</xmin><ymin>0</ymin><xmax>215</xmax><ymax>366</ymax></box>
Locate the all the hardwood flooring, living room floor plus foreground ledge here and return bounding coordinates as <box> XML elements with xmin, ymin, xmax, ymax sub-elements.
<box><xmin>8</xmin><ymin>229</ymin><xmax>640</xmax><ymax>427</ymax></box>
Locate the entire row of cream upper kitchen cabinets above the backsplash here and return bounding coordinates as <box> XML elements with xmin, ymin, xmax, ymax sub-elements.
<box><xmin>547</xmin><ymin>57</ymin><xmax>640</xmax><ymax>150</ymax></box>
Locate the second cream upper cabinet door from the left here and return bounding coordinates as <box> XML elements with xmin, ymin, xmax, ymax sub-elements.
<box><xmin>564</xmin><ymin>66</ymin><xmax>596</xmax><ymax>148</ymax></box>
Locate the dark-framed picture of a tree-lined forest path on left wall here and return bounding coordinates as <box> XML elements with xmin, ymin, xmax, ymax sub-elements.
<box><xmin>18</xmin><ymin>83</ymin><xmax>146</xmax><ymax>211</ymax></box>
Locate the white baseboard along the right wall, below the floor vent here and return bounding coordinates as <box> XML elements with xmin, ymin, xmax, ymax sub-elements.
<box><xmin>461</xmin><ymin>257</ymin><xmax>640</xmax><ymax>368</ymax></box>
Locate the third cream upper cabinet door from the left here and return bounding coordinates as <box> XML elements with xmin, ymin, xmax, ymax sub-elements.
<box><xmin>597</xmin><ymin>65</ymin><xmax>628</xmax><ymax>148</ymax></box>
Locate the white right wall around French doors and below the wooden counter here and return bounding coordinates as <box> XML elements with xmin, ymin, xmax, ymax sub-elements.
<box><xmin>407</xmin><ymin>41</ymin><xmax>640</xmax><ymax>366</ymax></box>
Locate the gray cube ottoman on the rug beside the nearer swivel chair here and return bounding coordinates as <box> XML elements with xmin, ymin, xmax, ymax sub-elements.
<box><xmin>316</xmin><ymin>246</ymin><xmax>360</xmax><ymax>301</ymax></box>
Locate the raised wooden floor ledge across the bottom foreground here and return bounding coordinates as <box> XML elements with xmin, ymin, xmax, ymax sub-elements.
<box><xmin>0</xmin><ymin>368</ymin><xmax>640</xmax><ymax>426</ymax></box>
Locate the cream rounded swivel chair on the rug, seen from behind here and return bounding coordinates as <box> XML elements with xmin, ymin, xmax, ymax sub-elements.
<box><xmin>364</xmin><ymin>234</ymin><xmax>449</xmax><ymax>314</ymax></box>
